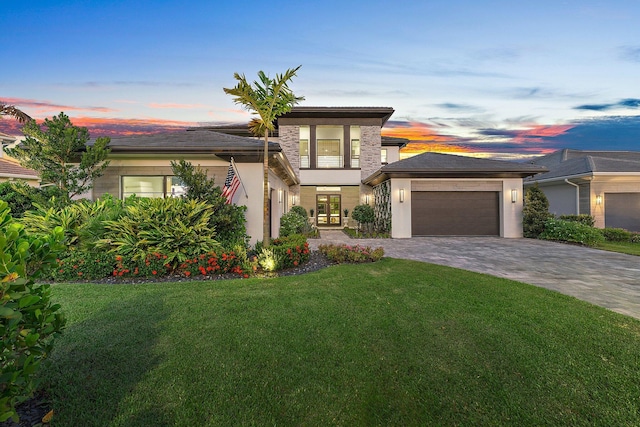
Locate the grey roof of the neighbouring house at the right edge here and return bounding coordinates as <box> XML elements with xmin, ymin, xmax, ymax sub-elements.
<box><xmin>527</xmin><ymin>149</ymin><xmax>640</xmax><ymax>182</ymax></box>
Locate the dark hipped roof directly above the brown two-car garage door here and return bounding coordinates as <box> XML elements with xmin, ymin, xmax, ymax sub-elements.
<box><xmin>363</xmin><ymin>152</ymin><xmax>547</xmax><ymax>185</ymax></box>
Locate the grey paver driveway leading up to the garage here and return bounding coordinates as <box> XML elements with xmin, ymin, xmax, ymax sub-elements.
<box><xmin>309</xmin><ymin>231</ymin><xmax>640</xmax><ymax>319</ymax></box>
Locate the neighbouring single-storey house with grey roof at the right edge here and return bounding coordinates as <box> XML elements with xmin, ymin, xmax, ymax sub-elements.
<box><xmin>525</xmin><ymin>149</ymin><xmax>640</xmax><ymax>231</ymax></box>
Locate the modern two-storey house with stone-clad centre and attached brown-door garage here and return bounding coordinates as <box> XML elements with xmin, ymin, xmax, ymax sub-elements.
<box><xmin>93</xmin><ymin>107</ymin><xmax>546</xmax><ymax>243</ymax></box>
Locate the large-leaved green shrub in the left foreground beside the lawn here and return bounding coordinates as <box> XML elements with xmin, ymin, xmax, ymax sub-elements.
<box><xmin>0</xmin><ymin>201</ymin><xmax>65</xmax><ymax>422</ymax></box>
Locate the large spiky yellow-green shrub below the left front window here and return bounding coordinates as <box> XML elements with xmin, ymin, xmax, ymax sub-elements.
<box><xmin>96</xmin><ymin>198</ymin><xmax>221</xmax><ymax>268</ymax></box>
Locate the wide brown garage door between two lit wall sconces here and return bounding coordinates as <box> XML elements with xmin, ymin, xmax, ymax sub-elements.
<box><xmin>411</xmin><ymin>191</ymin><xmax>500</xmax><ymax>236</ymax></box>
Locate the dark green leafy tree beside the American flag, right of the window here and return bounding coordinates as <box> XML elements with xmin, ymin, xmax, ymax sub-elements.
<box><xmin>171</xmin><ymin>160</ymin><xmax>247</xmax><ymax>248</ymax></box>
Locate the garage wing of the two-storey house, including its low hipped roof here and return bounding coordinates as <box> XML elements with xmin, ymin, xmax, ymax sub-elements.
<box><xmin>364</xmin><ymin>153</ymin><xmax>546</xmax><ymax>238</ymax></box>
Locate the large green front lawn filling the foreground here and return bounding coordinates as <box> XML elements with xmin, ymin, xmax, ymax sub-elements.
<box><xmin>44</xmin><ymin>258</ymin><xmax>640</xmax><ymax>426</ymax></box>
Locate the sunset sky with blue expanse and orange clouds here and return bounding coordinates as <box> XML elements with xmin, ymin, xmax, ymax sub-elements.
<box><xmin>0</xmin><ymin>0</ymin><xmax>640</xmax><ymax>160</ymax></box>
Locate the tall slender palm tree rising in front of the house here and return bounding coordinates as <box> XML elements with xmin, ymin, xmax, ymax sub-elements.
<box><xmin>223</xmin><ymin>65</ymin><xmax>304</xmax><ymax>246</ymax></box>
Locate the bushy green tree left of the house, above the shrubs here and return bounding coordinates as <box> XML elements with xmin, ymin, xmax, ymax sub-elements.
<box><xmin>7</xmin><ymin>113</ymin><xmax>111</xmax><ymax>199</ymax></box>
